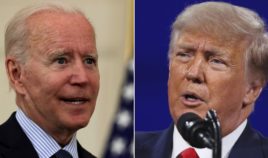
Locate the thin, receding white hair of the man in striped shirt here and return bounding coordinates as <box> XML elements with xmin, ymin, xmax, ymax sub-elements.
<box><xmin>5</xmin><ymin>2</ymin><xmax>85</xmax><ymax>64</ymax></box>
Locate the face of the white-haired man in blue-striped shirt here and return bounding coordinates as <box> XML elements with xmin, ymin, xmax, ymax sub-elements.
<box><xmin>17</xmin><ymin>12</ymin><xmax>100</xmax><ymax>132</ymax></box>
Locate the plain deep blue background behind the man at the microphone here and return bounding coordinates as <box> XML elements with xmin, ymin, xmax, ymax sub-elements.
<box><xmin>135</xmin><ymin>0</ymin><xmax>268</xmax><ymax>136</ymax></box>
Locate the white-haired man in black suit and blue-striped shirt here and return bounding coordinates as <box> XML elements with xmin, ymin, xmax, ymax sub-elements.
<box><xmin>0</xmin><ymin>3</ymin><xmax>100</xmax><ymax>158</ymax></box>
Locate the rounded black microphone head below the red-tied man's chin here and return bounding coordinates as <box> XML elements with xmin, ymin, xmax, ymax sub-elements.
<box><xmin>177</xmin><ymin>112</ymin><xmax>214</xmax><ymax>149</ymax></box>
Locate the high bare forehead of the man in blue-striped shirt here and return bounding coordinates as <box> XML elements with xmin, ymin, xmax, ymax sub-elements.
<box><xmin>27</xmin><ymin>11</ymin><xmax>96</xmax><ymax>55</ymax></box>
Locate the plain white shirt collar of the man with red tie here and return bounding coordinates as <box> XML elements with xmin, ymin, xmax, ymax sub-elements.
<box><xmin>171</xmin><ymin>120</ymin><xmax>247</xmax><ymax>158</ymax></box>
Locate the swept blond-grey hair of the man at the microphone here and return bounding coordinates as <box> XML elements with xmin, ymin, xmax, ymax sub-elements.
<box><xmin>169</xmin><ymin>2</ymin><xmax>268</xmax><ymax>83</ymax></box>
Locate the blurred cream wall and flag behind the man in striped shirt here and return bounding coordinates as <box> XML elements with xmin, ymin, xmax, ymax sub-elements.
<box><xmin>0</xmin><ymin>0</ymin><xmax>133</xmax><ymax>157</ymax></box>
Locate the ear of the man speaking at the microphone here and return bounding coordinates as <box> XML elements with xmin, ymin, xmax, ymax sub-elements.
<box><xmin>243</xmin><ymin>79</ymin><xmax>264</xmax><ymax>107</ymax></box>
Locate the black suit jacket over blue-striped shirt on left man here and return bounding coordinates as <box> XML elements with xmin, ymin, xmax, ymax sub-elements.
<box><xmin>0</xmin><ymin>113</ymin><xmax>95</xmax><ymax>158</ymax></box>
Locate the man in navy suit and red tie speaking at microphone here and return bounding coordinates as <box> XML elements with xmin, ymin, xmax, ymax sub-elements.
<box><xmin>135</xmin><ymin>2</ymin><xmax>268</xmax><ymax>158</ymax></box>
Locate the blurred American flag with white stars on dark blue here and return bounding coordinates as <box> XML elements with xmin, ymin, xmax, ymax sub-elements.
<box><xmin>103</xmin><ymin>61</ymin><xmax>134</xmax><ymax>158</ymax></box>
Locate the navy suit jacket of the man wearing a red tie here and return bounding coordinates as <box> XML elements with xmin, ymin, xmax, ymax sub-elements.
<box><xmin>135</xmin><ymin>123</ymin><xmax>268</xmax><ymax>158</ymax></box>
